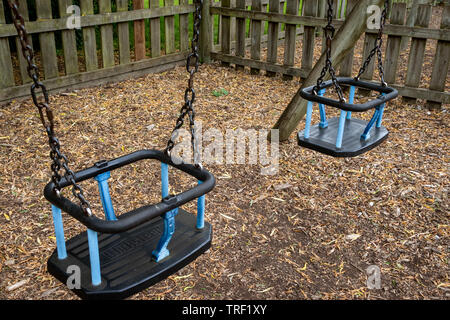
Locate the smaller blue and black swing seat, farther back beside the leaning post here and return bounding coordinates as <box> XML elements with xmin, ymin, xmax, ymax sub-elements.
<box><xmin>297</xmin><ymin>78</ymin><xmax>398</xmax><ymax>157</ymax></box>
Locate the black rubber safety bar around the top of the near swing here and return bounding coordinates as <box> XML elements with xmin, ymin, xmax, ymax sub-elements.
<box><xmin>44</xmin><ymin>150</ymin><xmax>216</xmax><ymax>233</ymax></box>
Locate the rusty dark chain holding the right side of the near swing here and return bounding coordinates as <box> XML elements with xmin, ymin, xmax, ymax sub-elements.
<box><xmin>165</xmin><ymin>0</ymin><xmax>203</xmax><ymax>166</ymax></box>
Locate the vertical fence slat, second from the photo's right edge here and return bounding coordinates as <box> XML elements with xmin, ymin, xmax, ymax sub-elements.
<box><xmin>403</xmin><ymin>4</ymin><xmax>432</xmax><ymax>104</ymax></box>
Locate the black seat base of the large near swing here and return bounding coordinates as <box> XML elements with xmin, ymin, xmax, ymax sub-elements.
<box><xmin>47</xmin><ymin>208</ymin><xmax>212</xmax><ymax>299</ymax></box>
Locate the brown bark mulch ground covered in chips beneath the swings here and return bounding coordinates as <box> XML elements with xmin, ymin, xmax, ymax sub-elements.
<box><xmin>0</xmin><ymin>8</ymin><xmax>450</xmax><ymax>299</ymax></box>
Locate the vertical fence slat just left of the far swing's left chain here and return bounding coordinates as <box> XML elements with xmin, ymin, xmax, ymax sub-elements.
<box><xmin>302</xmin><ymin>0</ymin><xmax>317</xmax><ymax>79</ymax></box>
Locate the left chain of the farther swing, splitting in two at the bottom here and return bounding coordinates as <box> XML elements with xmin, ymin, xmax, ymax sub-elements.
<box><xmin>313</xmin><ymin>0</ymin><xmax>345</xmax><ymax>102</ymax></box>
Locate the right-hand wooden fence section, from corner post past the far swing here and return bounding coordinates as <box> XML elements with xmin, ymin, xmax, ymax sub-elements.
<box><xmin>210</xmin><ymin>0</ymin><xmax>450</xmax><ymax>107</ymax></box>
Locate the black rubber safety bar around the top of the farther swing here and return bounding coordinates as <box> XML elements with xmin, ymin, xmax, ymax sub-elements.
<box><xmin>300</xmin><ymin>78</ymin><xmax>398</xmax><ymax>112</ymax></box>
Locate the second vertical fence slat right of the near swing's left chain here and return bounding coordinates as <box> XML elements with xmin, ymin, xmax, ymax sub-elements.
<box><xmin>58</xmin><ymin>0</ymin><xmax>78</xmax><ymax>74</ymax></box>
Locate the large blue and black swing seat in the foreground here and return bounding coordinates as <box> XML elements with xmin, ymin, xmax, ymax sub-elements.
<box><xmin>44</xmin><ymin>150</ymin><xmax>215</xmax><ymax>299</ymax></box>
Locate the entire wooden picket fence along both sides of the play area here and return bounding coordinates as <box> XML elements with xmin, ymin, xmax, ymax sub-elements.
<box><xmin>0</xmin><ymin>0</ymin><xmax>450</xmax><ymax>106</ymax></box>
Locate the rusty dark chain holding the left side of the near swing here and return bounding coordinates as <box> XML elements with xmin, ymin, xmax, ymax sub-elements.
<box><xmin>8</xmin><ymin>0</ymin><xmax>92</xmax><ymax>216</ymax></box>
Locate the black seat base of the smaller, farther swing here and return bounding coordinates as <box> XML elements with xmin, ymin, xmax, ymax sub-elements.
<box><xmin>297</xmin><ymin>117</ymin><xmax>389</xmax><ymax>157</ymax></box>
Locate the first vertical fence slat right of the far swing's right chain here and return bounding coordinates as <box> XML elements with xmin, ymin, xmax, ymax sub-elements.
<box><xmin>384</xmin><ymin>3</ymin><xmax>406</xmax><ymax>84</ymax></box>
